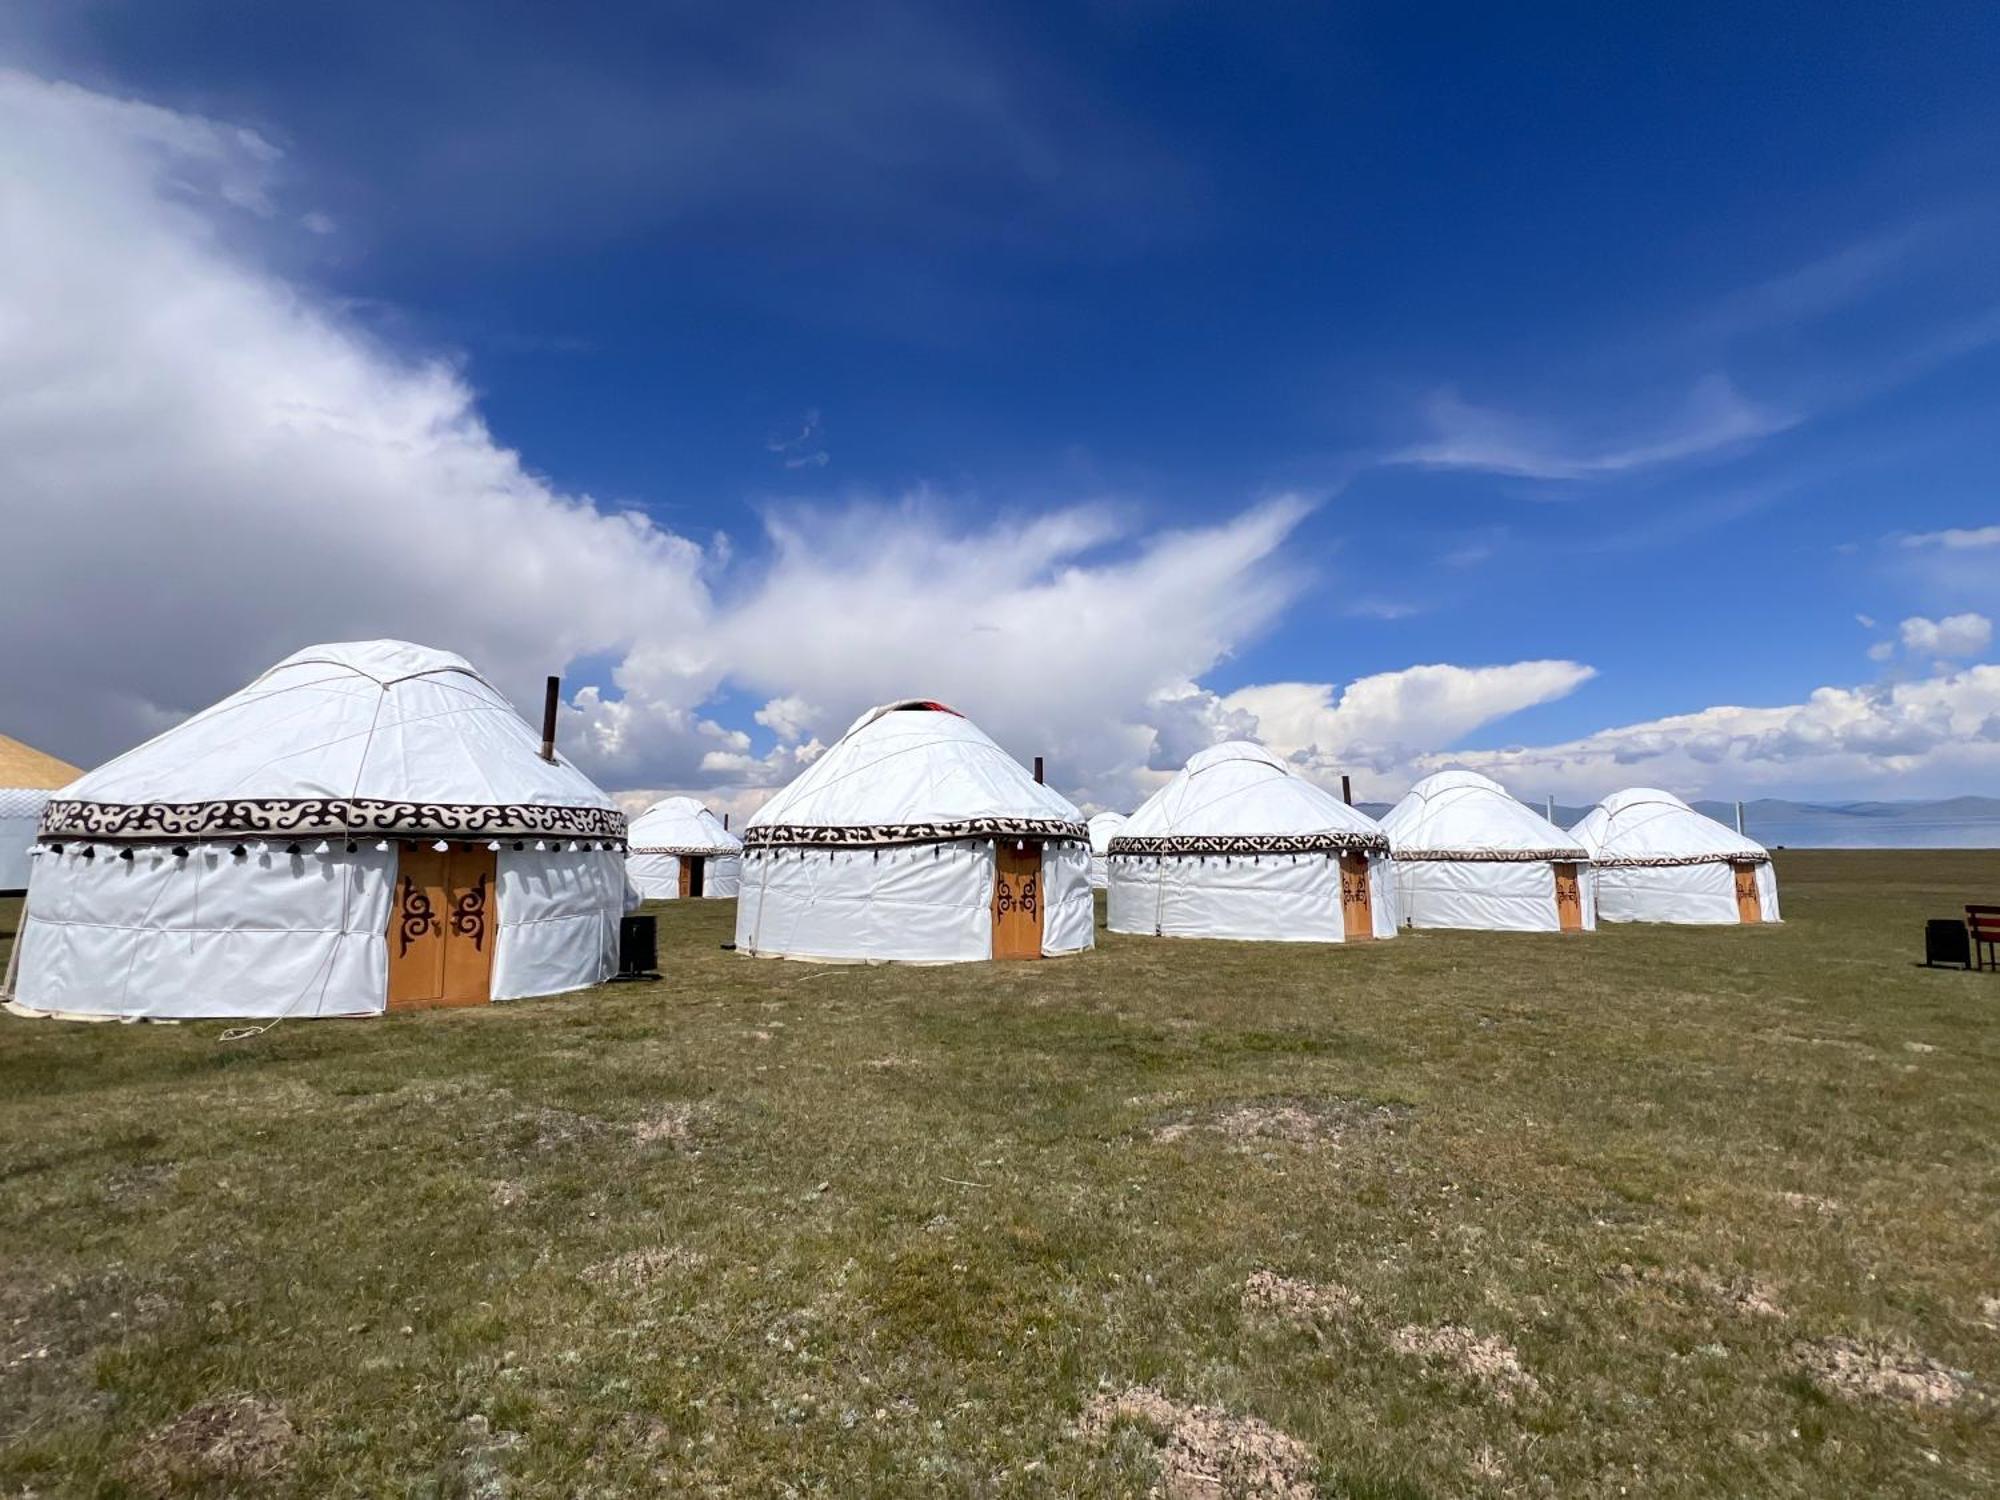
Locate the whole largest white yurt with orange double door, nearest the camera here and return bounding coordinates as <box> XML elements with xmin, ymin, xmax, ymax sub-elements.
<box><xmin>3</xmin><ymin>640</ymin><xmax>626</xmax><ymax>1020</ymax></box>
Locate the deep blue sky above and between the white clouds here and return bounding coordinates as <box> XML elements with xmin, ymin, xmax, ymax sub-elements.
<box><xmin>0</xmin><ymin>4</ymin><xmax>2000</xmax><ymax>816</ymax></box>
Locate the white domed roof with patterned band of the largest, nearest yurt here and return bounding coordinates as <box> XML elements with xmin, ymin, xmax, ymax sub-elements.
<box><xmin>42</xmin><ymin>640</ymin><xmax>624</xmax><ymax>838</ymax></box>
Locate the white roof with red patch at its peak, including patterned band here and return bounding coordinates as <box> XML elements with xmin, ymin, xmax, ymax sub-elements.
<box><xmin>744</xmin><ymin>698</ymin><xmax>1088</xmax><ymax>848</ymax></box>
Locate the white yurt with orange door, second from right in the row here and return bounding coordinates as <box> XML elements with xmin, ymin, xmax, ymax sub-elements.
<box><xmin>1382</xmin><ymin>770</ymin><xmax>1598</xmax><ymax>932</ymax></box>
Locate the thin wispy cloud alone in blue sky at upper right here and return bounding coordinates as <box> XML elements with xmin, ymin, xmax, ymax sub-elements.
<box><xmin>1392</xmin><ymin>374</ymin><xmax>1796</xmax><ymax>480</ymax></box>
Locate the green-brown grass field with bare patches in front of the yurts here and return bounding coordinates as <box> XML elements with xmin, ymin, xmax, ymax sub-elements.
<box><xmin>0</xmin><ymin>852</ymin><xmax>2000</xmax><ymax>1496</ymax></box>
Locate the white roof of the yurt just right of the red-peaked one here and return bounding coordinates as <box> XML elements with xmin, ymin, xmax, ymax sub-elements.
<box><xmin>1110</xmin><ymin>740</ymin><xmax>1388</xmax><ymax>854</ymax></box>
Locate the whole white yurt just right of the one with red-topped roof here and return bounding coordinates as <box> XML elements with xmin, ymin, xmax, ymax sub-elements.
<box><xmin>1108</xmin><ymin>740</ymin><xmax>1396</xmax><ymax>942</ymax></box>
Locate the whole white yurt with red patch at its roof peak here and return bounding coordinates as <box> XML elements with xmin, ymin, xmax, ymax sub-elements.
<box><xmin>736</xmin><ymin>698</ymin><xmax>1094</xmax><ymax>964</ymax></box>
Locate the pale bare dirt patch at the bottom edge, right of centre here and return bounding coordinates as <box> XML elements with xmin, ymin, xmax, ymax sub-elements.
<box><xmin>1078</xmin><ymin>1386</ymin><xmax>1318</xmax><ymax>1500</ymax></box>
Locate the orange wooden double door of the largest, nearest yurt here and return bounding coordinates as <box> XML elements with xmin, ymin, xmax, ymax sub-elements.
<box><xmin>388</xmin><ymin>844</ymin><xmax>500</xmax><ymax>1010</ymax></box>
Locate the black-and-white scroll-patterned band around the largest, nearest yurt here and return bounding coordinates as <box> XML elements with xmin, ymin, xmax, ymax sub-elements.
<box><xmin>42</xmin><ymin>796</ymin><xmax>626</xmax><ymax>842</ymax></box>
